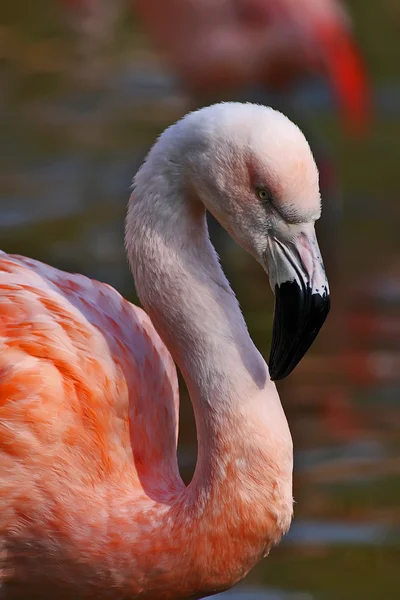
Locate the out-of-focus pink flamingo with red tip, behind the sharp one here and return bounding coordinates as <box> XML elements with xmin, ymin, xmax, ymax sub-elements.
<box><xmin>62</xmin><ymin>0</ymin><xmax>370</xmax><ymax>131</ymax></box>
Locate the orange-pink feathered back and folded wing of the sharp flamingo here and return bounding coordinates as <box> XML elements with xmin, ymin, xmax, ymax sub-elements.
<box><xmin>0</xmin><ymin>253</ymin><xmax>180</xmax><ymax>579</ymax></box>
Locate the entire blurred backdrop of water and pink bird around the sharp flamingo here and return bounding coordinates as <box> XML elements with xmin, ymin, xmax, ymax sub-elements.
<box><xmin>0</xmin><ymin>0</ymin><xmax>400</xmax><ymax>600</ymax></box>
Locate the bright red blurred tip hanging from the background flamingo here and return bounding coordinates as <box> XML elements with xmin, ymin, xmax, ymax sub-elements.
<box><xmin>316</xmin><ymin>24</ymin><xmax>371</xmax><ymax>134</ymax></box>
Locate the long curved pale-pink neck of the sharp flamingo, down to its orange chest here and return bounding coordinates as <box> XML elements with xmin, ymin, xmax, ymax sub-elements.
<box><xmin>126</xmin><ymin>162</ymin><xmax>292</xmax><ymax>586</ymax></box>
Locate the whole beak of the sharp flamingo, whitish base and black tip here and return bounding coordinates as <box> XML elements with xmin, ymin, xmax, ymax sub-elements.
<box><xmin>266</xmin><ymin>225</ymin><xmax>330</xmax><ymax>380</ymax></box>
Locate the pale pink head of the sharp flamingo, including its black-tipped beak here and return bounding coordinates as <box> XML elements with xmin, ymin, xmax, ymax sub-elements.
<box><xmin>181</xmin><ymin>103</ymin><xmax>330</xmax><ymax>379</ymax></box>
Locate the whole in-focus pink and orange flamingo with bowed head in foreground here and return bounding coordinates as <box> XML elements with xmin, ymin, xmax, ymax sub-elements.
<box><xmin>0</xmin><ymin>103</ymin><xmax>329</xmax><ymax>600</ymax></box>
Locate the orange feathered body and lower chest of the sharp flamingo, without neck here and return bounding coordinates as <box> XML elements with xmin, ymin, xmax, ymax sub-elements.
<box><xmin>0</xmin><ymin>252</ymin><xmax>287</xmax><ymax>600</ymax></box>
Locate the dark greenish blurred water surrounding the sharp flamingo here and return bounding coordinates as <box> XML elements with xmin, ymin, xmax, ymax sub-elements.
<box><xmin>0</xmin><ymin>0</ymin><xmax>400</xmax><ymax>600</ymax></box>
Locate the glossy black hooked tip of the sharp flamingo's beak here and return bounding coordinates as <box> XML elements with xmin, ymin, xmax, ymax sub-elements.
<box><xmin>268</xmin><ymin>281</ymin><xmax>330</xmax><ymax>381</ymax></box>
